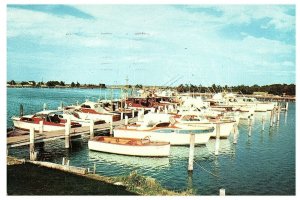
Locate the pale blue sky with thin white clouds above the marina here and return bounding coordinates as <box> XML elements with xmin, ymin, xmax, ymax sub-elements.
<box><xmin>7</xmin><ymin>5</ymin><xmax>296</xmax><ymax>86</ymax></box>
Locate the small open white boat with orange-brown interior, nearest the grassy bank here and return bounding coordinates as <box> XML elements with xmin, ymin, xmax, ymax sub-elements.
<box><xmin>88</xmin><ymin>136</ymin><xmax>170</xmax><ymax>157</ymax></box>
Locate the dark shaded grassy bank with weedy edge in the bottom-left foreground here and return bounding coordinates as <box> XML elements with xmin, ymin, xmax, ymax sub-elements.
<box><xmin>7</xmin><ymin>157</ymin><xmax>192</xmax><ymax>195</ymax></box>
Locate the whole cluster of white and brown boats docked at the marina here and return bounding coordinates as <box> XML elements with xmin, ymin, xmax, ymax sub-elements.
<box><xmin>12</xmin><ymin>91</ymin><xmax>275</xmax><ymax>156</ymax></box>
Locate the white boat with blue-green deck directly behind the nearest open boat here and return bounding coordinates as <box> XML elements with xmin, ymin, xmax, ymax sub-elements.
<box><xmin>114</xmin><ymin>122</ymin><xmax>214</xmax><ymax>145</ymax></box>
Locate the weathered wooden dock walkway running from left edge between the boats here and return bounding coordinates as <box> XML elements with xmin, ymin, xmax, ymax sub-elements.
<box><xmin>7</xmin><ymin>117</ymin><xmax>137</xmax><ymax>148</ymax></box>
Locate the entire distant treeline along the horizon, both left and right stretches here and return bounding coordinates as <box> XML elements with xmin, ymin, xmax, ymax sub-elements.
<box><xmin>7</xmin><ymin>80</ymin><xmax>296</xmax><ymax>96</ymax></box>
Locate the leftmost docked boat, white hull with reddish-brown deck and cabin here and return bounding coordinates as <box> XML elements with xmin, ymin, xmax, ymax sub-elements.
<box><xmin>11</xmin><ymin>110</ymin><xmax>81</xmax><ymax>131</ymax></box>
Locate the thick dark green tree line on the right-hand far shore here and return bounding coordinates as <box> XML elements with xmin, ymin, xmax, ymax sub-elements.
<box><xmin>176</xmin><ymin>84</ymin><xmax>296</xmax><ymax>96</ymax></box>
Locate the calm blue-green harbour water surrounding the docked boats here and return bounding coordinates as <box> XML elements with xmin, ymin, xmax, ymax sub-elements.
<box><xmin>7</xmin><ymin>89</ymin><xmax>295</xmax><ymax>195</ymax></box>
